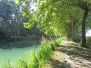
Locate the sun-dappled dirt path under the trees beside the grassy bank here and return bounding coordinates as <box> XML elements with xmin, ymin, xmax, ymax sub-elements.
<box><xmin>43</xmin><ymin>41</ymin><xmax>91</xmax><ymax>68</ymax></box>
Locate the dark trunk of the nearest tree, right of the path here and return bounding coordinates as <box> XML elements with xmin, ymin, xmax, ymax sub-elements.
<box><xmin>81</xmin><ymin>11</ymin><xmax>88</xmax><ymax>47</ymax></box>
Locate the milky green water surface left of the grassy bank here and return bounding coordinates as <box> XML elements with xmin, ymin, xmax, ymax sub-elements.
<box><xmin>0</xmin><ymin>41</ymin><xmax>40</xmax><ymax>66</ymax></box>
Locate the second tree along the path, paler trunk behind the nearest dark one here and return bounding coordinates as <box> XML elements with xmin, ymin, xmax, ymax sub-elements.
<box><xmin>60</xmin><ymin>7</ymin><xmax>82</xmax><ymax>41</ymax></box>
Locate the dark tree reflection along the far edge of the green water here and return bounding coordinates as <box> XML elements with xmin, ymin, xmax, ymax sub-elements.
<box><xmin>0</xmin><ymin>40</ymin><xmax>40</xmax><ymax>49</ymax></box>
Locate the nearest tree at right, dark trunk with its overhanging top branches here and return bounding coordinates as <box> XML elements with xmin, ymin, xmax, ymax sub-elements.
<box><xmin>62</xmin><ymin>0</ymin><xmax>91</xmax><ymax>47</ymax></box>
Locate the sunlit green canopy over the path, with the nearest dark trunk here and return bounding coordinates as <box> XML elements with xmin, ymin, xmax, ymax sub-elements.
<box><xmin>16</xmin><ymin>0</ymin><xmax>91</xmax><ymax>47</ymax></box>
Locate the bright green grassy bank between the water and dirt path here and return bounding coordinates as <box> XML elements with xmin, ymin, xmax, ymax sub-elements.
<box><xmin>2</xmin><ymin>39</ymin><xmax>62</xmax><ymax>68</ymax></box>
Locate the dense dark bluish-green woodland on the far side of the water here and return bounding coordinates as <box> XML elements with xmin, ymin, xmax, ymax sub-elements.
<box><xmin>0</xmin><ymin>0</ymin><xmax>49</xmax><ymax>41</ymax></box>
